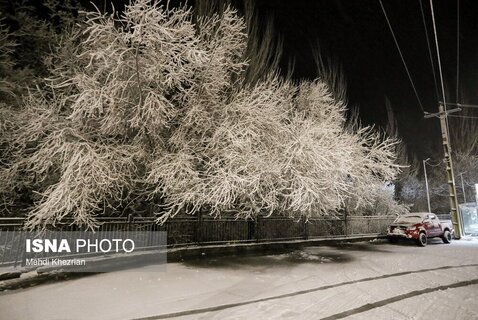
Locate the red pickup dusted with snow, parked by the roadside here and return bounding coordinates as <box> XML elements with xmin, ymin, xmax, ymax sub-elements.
<box><xmin>387</xmin><ymin>212</ymin><xmax>453</xmax><ymax>247</ymax></box>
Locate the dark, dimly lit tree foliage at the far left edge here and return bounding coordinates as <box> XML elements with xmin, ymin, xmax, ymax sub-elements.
<box><xmin>0</xmin><ymin>0</ymin><xmax>84</xmax><ymax>214</ymax></box>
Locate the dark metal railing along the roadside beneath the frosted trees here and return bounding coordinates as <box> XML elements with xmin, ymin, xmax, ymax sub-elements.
<box><xmin>0</xmin><ymin>216</ymin><xmax>395</xmax><ymax>266</ymax></box>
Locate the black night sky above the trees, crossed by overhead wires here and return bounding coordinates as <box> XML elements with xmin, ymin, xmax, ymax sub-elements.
<box><xmin>252</xmin><ymin>0</ymin><xmax>478</xmax><ymax>159</ymax></box>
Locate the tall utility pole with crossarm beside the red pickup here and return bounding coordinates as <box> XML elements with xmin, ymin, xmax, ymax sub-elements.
<box><xmin>425</xmin><ymin>102</ymin><xmax>461</xmax><ymax>239</ymax></box>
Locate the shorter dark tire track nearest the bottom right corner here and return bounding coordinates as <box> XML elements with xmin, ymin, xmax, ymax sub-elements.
<box><xmin>321</xmin><ymin>279</ymin><xmax>478</xmax><ymax>320</ymax></box>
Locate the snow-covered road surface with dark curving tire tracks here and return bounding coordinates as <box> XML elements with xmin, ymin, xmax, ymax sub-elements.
<box><xmin>0</xmin><ymin>240</ymin><xmax>478</xmax><ymax>320</ymax></box>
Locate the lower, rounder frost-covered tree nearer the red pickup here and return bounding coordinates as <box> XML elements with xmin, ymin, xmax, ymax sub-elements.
<box><xmin>149</xmin><ymin>78</ymin><xmax>398</xmax><ymax>222</ymax></box>
